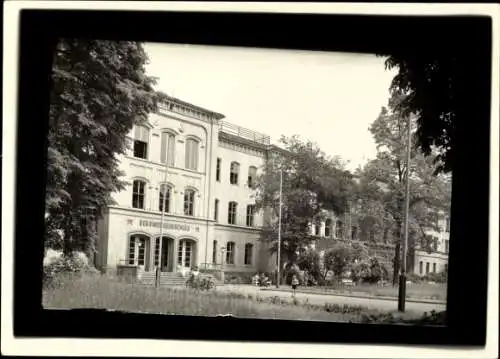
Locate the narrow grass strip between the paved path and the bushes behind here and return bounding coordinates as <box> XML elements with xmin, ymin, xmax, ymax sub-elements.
<box><xmin>276</xmin><ymin>283</ymin><xmax>446</xmax><ymax>301</ymax></box>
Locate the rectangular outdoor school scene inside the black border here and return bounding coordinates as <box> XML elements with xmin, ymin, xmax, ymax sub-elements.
<box><xmin>42</xmin><ymin>39</ymin><xmax>453</xmax><ymax>325</ymax></box>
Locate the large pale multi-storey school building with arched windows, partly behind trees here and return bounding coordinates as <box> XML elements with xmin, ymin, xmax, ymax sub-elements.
<box><xmin>95</xmin><ymin>98</ymin><xmax>448</xmax><ymax>275</ymax></box>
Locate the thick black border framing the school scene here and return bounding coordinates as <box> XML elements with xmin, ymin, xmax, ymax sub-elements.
<box><xmin>14</xmin><ymin>10</ymin><xmax>492</xmax><ymax>345</ymax></box>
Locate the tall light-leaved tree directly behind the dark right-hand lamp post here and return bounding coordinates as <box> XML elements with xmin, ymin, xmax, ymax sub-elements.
<box><xmin>357</xmin><ymin>94</ymin><xmax>451</xmax><ymax>284</ymax></box>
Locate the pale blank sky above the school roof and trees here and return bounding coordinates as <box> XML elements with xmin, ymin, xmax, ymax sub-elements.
<box><xmin>145</xmin><ymin>43</ymin><xmax>395</xmax><ymax>170</ymax></box>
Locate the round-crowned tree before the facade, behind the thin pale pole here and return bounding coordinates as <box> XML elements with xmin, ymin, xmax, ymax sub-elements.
<box><xmin>256</xmin><ymin>136</ymin><xmax>352</xmax><ymax>276</ymax></box>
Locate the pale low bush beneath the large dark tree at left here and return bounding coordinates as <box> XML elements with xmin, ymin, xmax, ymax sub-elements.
<box><xmin>43</xmin><ymin>253</ymin><xmax>100</xmax><ymax>287</ymax></box>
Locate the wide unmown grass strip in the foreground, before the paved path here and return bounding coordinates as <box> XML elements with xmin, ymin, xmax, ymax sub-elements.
<box><xmin>42</xmin><ymin>275</ymin><xmax>424</xmax><ymax>322</ymax></box>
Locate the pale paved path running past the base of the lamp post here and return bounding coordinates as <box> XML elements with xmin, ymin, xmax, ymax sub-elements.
<box><xmin>217</xmin><ymin>285</ymin><xmax>446</xmax><ymax>314</ymax></box>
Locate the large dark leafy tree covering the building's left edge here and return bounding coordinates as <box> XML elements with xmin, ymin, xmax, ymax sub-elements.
<box><xmin>46</xmin><ymin>39</ymin><xmax>163</xmax><ymax>256</ymax></box>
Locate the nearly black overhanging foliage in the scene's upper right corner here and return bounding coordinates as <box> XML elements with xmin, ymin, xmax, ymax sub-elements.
<box><xmin>385</xmin><ymin>50</ymin><xmax>470</xmax><ymax>176</ymax></box>
